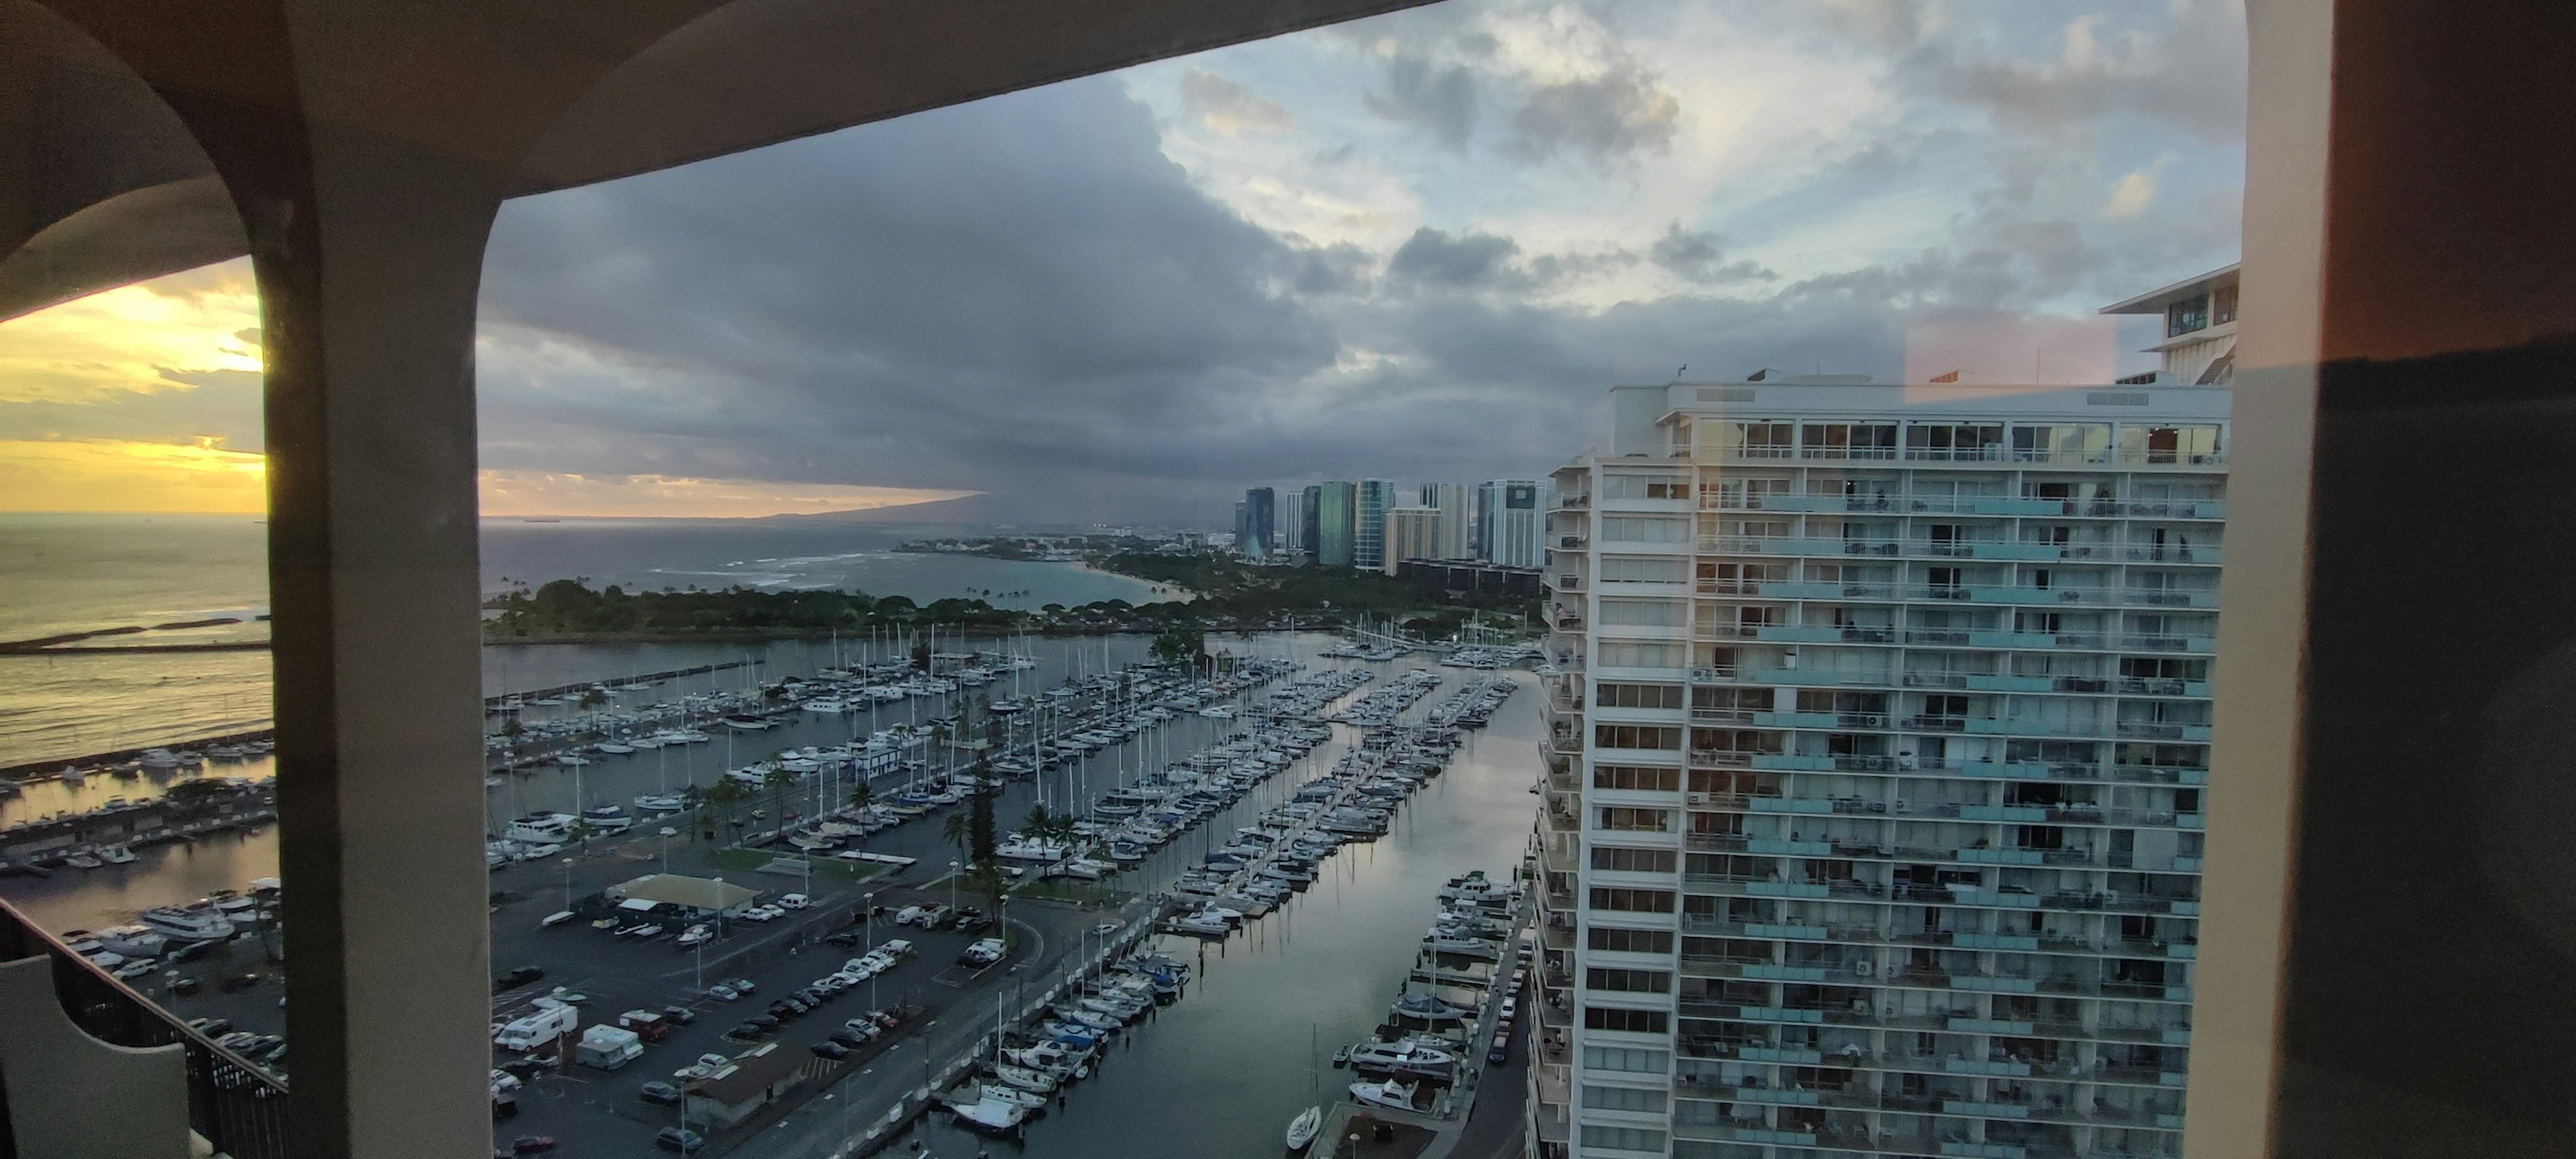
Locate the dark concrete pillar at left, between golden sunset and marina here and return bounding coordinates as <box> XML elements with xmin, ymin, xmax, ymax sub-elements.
<box><xmin>250</xmin><ymin>145</ymin><xmax>500</xmax><ymax>1159</ymax></box>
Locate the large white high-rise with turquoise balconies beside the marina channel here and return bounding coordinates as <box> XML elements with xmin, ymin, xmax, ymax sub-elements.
<box><xmin>1530</xmin><ymin>378</ymin><xmax>2229</xmax><ymax>1159</ymax></box>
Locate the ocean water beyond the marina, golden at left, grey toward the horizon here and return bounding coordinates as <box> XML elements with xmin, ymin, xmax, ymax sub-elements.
<box><xmin>0</xmin><ymin>515</ymin><xmax>1177</xmax><ymax>765</ymax></box>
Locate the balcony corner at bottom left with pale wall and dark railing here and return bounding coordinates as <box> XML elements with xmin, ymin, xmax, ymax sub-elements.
<box><xmin>0</xmin><ymin>901</ymin><xmax>288</xmax><ymax>1159</ymax></box>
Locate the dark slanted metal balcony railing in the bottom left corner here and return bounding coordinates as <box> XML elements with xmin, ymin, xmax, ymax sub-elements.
<box><xmin>0</xmin><ymin>901</ymin><xmax>286</xmax><ymax>1159</ymax></box>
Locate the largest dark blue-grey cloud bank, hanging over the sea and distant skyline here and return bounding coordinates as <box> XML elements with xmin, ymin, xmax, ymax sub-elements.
<box><xmin>479</xmin><ymin>66</ymin><xmax>2184</xmax><ymax>523</ymax></box>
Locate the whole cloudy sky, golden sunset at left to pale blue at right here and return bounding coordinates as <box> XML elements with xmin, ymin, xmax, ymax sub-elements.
<box><xmin>0</xmin><ymin>0</ymin><xmax>2244</xmax><ymax>523</ymax></box>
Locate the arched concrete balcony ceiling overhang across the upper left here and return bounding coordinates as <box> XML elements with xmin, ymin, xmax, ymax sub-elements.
<box><xmin>0</xmin><ymin>0</ymin><xmax>1425</xmax><ymax>319</ymax></box>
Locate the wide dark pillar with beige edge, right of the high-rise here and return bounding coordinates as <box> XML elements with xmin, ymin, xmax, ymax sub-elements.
<box><xmin>2187</xmin><ymin>0</ymin><xmax>2576</xmax><ymax>1159</ymax></box>
